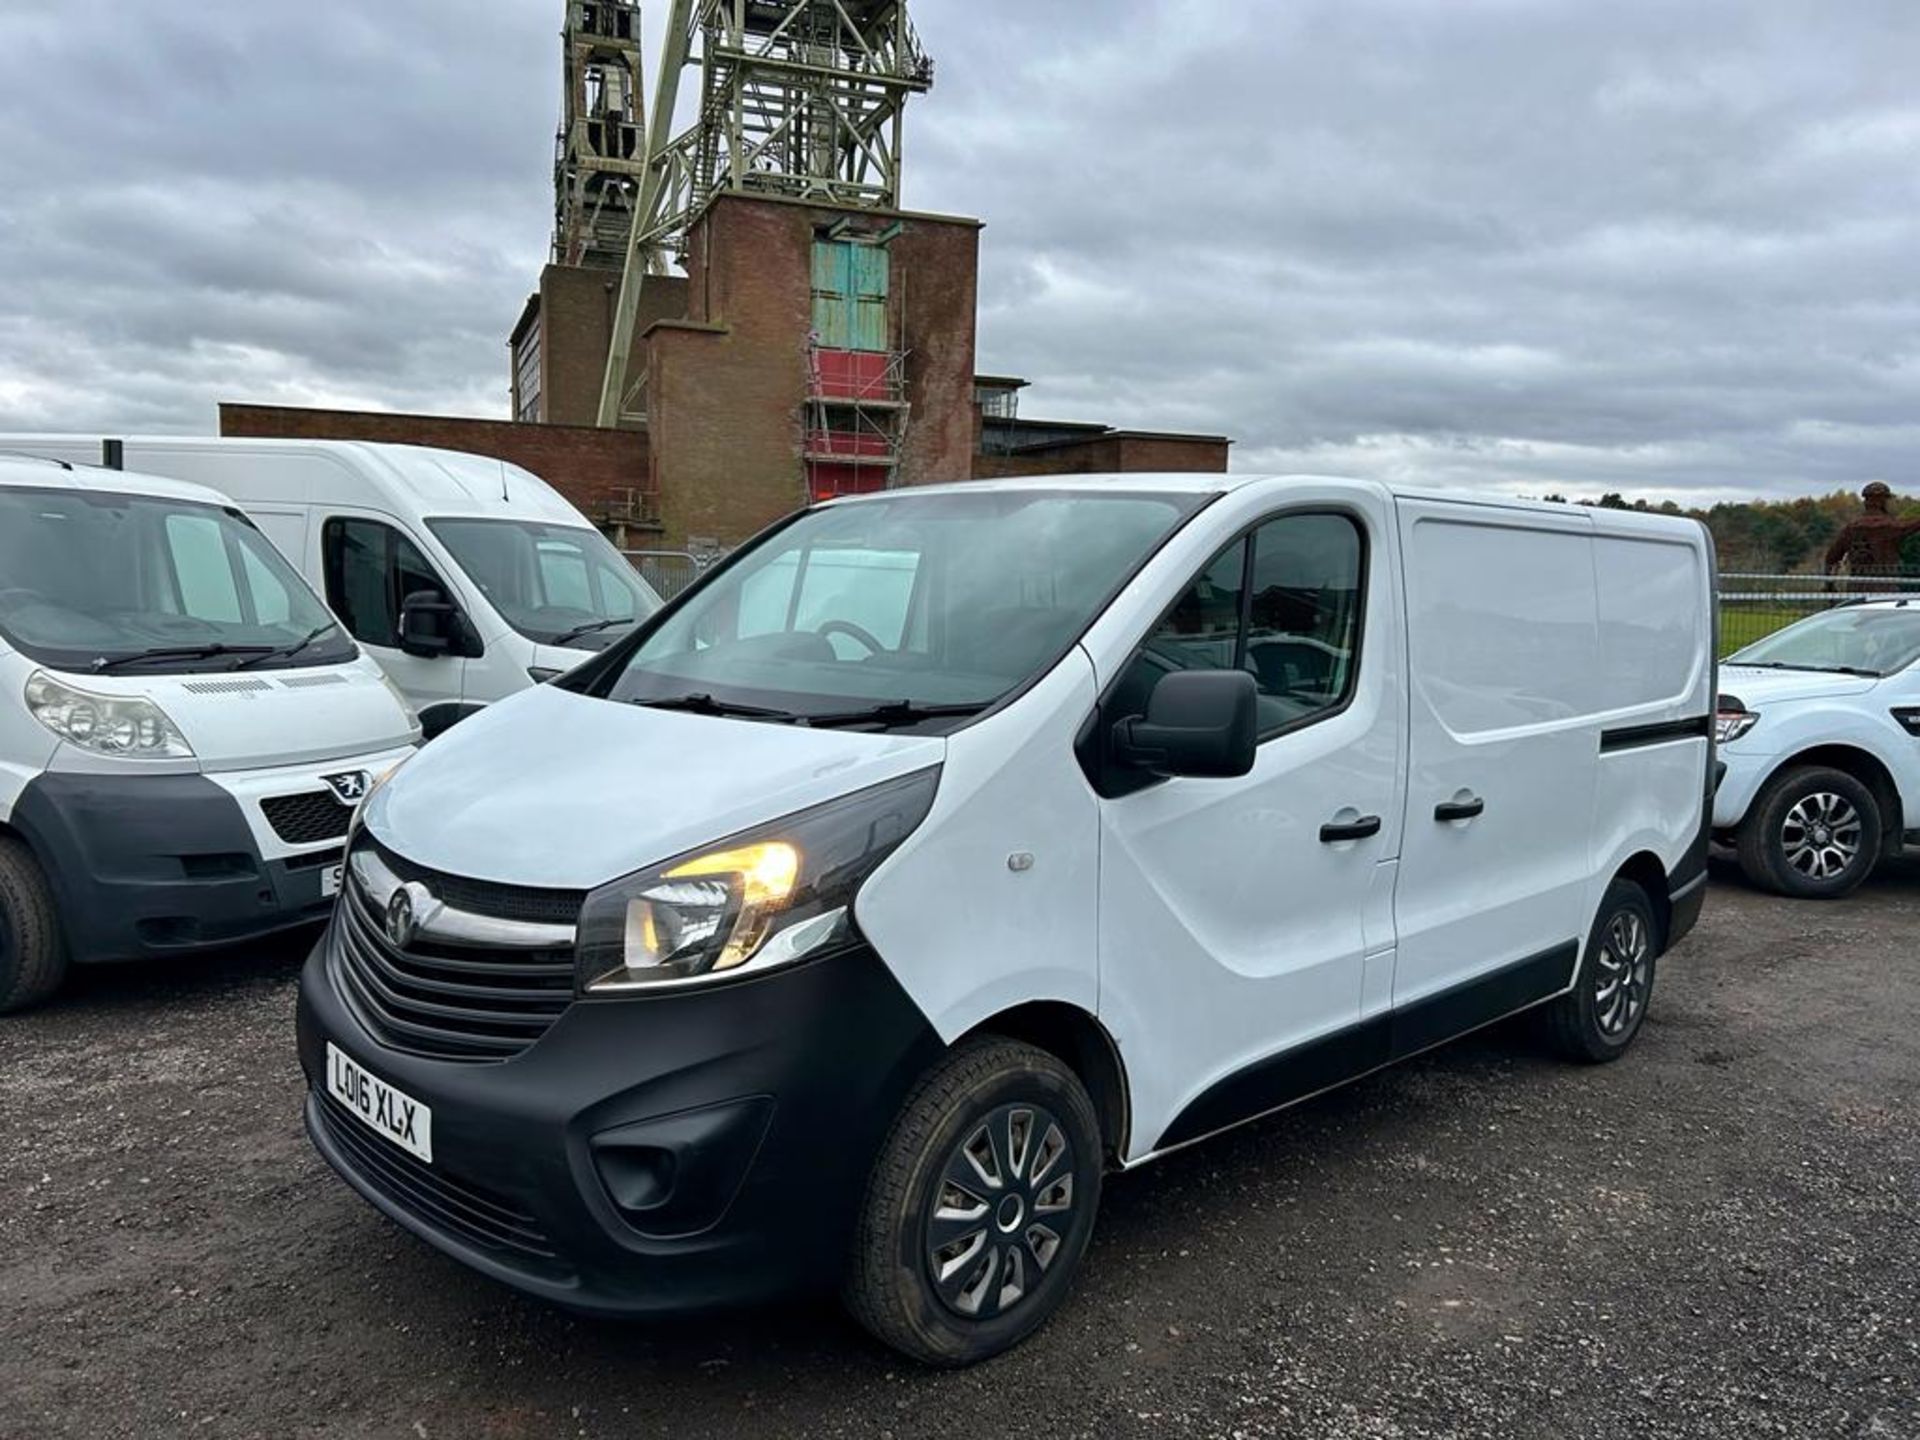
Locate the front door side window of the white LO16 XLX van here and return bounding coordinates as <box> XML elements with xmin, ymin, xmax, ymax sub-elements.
<box><xmin>1112</xmin><ymin>515</ymin><xmax>1365</xmax><ymax>739</ymax></box>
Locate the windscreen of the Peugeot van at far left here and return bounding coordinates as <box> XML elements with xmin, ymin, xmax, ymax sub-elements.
<box><xmin>0</xmin><ymin>488</ymin><xmax>357</xmax><ymax>674</ymax></box>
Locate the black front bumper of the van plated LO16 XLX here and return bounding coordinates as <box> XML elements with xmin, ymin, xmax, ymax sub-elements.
<box><xmin>300</xmin><ymin>925</ymin><xmax>941</xmax><ymax>1315</ymax></box>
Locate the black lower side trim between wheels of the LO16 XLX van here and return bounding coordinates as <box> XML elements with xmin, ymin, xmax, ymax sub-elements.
<box><xmin>1154</xmin><ymin>941</ymin><xmax>1580</xmax><ymax>1150</ymax></box>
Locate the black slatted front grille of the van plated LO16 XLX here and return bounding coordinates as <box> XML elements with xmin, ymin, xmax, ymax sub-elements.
<box><xmin>328</xmin><ymin>852</ymin><xmax>578</xmax><ymax>1062</ymax></box>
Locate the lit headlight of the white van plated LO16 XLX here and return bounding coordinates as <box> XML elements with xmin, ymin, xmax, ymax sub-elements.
<box><xmin>576</xmin><ymin>770</ymin><xmax>939</xmax><ymax>995</ymax></box>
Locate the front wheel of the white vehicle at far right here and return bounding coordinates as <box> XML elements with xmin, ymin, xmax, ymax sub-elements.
<box><xmin>1740</xmin><ymin>766</ymin><xmax>1882</xmax><ymax>900</ymax></box>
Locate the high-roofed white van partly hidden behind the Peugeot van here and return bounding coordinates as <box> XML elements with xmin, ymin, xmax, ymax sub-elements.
<box><xmin>0</xmin><ymin>436</ymin><xmax>660</xmax><ymax>739</ymax></box>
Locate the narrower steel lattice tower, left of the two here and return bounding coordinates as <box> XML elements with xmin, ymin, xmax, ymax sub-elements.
<box><xmin>553</xmin><ymin>0</ymin><xmax>647</xmax><ymax>269</ymax></box>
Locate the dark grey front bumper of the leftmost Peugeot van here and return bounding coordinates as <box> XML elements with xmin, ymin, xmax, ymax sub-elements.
<box><xmin>12</xmin><ymin>772</ymin><xmax>340</xmax><ymax>964</ymax></box>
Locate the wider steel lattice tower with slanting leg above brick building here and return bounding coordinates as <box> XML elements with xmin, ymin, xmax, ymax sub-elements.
<box><xmin>595</xmin><ymin>0</ymin><xmax>933</xmax><ymax>426</ymax></box>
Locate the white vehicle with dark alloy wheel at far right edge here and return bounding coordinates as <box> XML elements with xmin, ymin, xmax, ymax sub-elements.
<box><xmin>1713</xmin><ymin>595</ymin><xmax>1920</xmax><ymax>900</ymax></box>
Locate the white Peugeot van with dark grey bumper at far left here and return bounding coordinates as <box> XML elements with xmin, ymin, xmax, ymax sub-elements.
<box><xmin>0</xmin><ymin>457</ymin><xmax>420</xmax><ymax>1014</ymax></box>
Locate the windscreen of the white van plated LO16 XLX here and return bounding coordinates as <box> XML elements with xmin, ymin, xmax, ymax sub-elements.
<box><xmin>586</xmin><ymin>490</ymin><xmax>1208</xmax><ymax>728</ymax></box>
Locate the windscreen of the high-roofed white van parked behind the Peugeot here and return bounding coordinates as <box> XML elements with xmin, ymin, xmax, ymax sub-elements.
<box><xmin>426</xmin><ymin>520</ymin><xmax>660</xmax><ymax>649</ymax></box>
